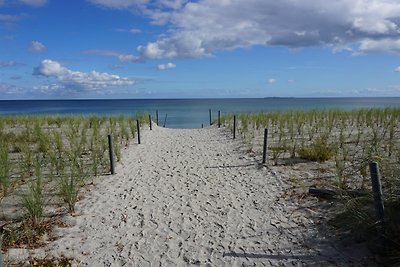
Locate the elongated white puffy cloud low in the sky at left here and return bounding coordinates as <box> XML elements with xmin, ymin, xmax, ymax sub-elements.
<box><xmin>33</xmin><ymin>59</ymin><xmax>135</xmax><ymax>90</ymax></box>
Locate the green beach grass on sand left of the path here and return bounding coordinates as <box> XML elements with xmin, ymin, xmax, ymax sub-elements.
<box><xmin>0</xmin><ymin>114</ymin><xmax>148</xmax><ymax>252</ymax></box>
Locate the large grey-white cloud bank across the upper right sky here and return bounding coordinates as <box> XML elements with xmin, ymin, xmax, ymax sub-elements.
<box><xmin>90</xmin><ymin>0</ymin><xmax>400</xmax><ymax>59</ymax></box>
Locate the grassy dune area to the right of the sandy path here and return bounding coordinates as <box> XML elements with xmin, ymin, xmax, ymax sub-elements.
<box><xmin>221</xmin><ymin>108</ymin><xmax>400</xmax><ymax>264</ymax></box>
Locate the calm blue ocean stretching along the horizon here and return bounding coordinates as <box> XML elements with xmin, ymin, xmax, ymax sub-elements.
<box><xmin>0</xmin><ymin>97</ymin><xmax>400</xmax><ymax>128</ymax></box>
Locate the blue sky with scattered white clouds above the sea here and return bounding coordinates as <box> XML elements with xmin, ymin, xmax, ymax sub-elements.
<box><xmin>0</xmin><ymin>0</ymin><xmax>400</xmax><ymax>99</ymax></box>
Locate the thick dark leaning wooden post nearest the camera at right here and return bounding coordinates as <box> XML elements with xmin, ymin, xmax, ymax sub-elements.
<box><xmin>369</xmin><ymin>161</ymin><xmax>385</xmax><ymax>253</ymax></box>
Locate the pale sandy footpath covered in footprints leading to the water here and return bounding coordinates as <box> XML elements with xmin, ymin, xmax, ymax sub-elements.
<box><xmin>10</xmin><ymin>124</ymin><xmax>374</xmax><ymax>266</ymax></box>
